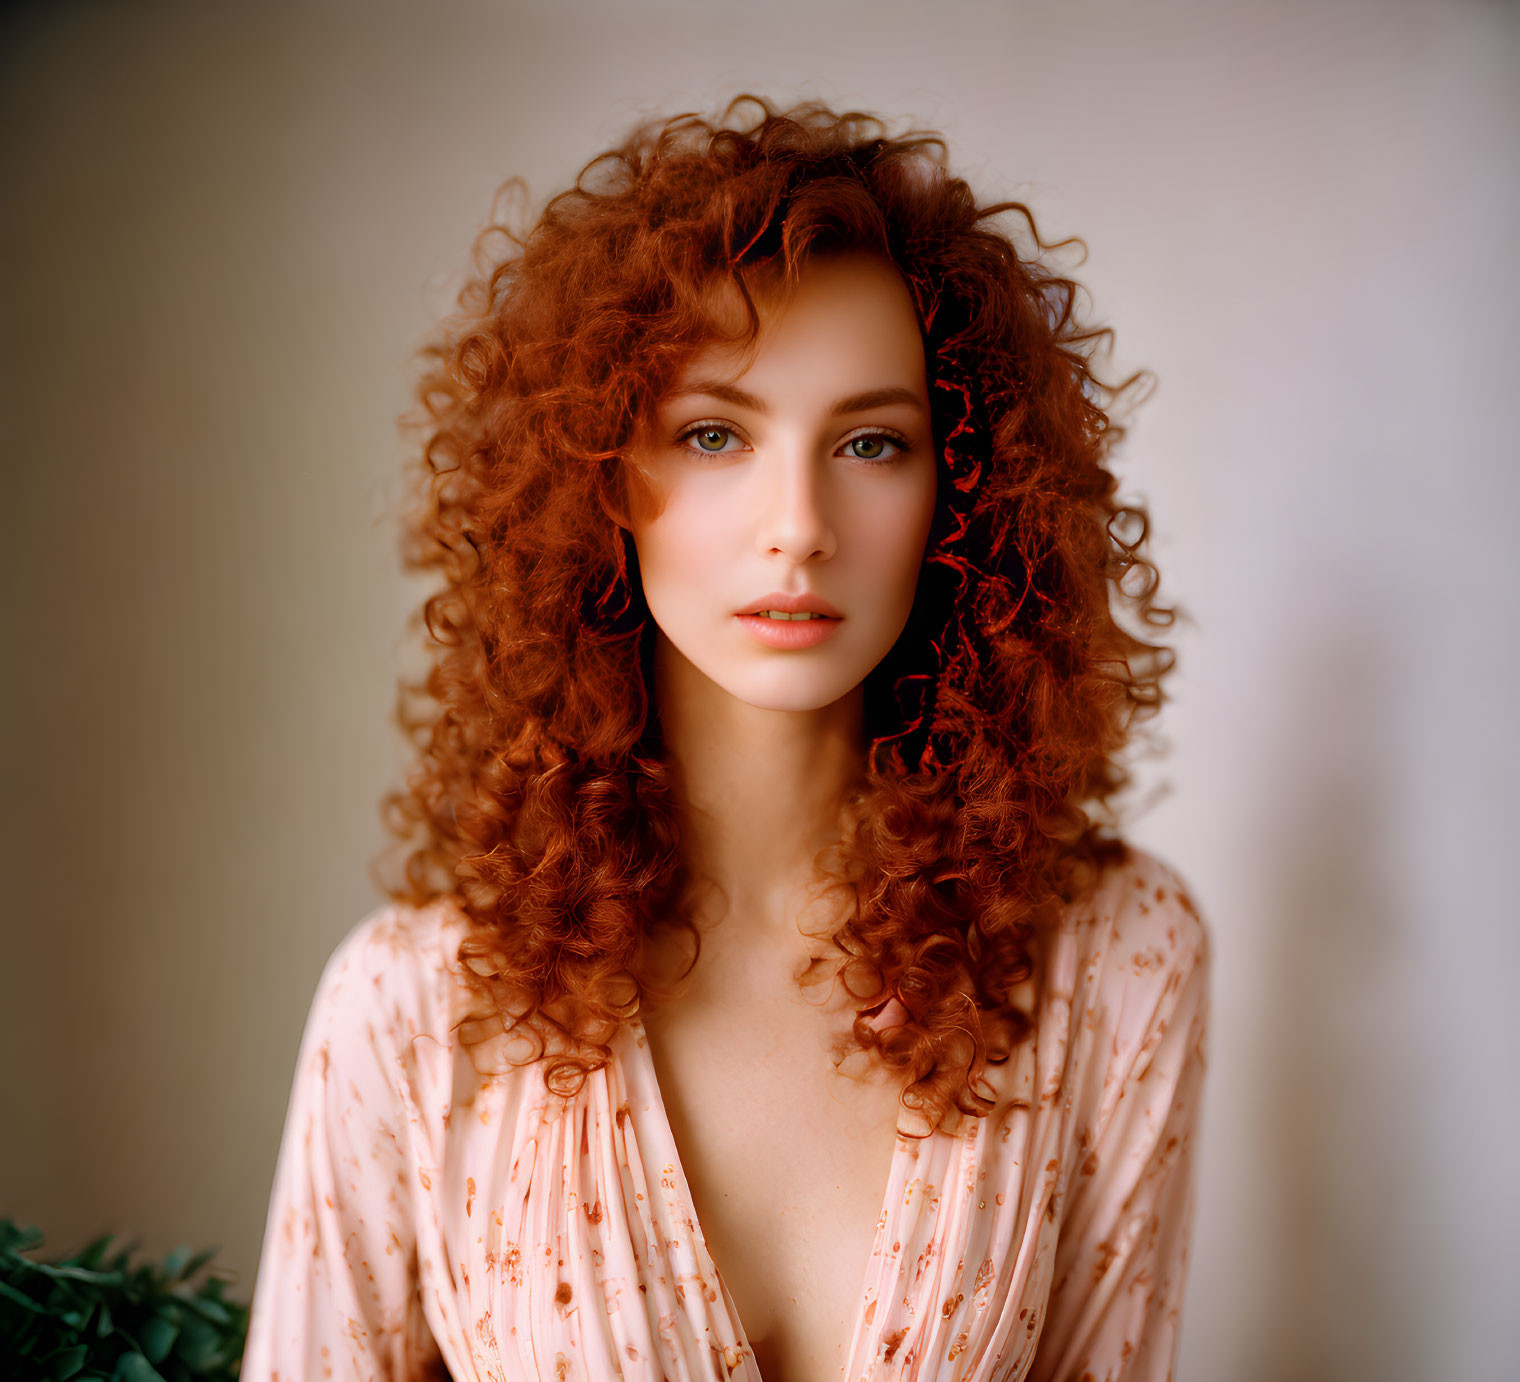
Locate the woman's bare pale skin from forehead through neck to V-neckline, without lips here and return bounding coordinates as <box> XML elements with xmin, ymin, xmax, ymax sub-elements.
<box><xmin>617</xmin><ymin>252</ymin><xmax>936</xmax><ymax>1382</ymax></box>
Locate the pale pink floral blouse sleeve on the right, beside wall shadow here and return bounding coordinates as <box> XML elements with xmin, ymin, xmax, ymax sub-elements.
<box><xmin>1029</xmin><ymin>861</ymin><xmax>1211</xmax><ymax>1382</ymax></box>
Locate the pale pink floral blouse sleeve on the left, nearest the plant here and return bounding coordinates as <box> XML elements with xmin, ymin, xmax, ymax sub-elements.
<box><xmin>242</xmin><ymin>914</ymin><xmax>447</xmax><ymax>1382</ymax></box>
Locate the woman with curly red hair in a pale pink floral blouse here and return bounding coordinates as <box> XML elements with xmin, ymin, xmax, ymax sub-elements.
<box><xmin>243</xmin><ymin>99</ymin><xmax>1208</xmax><ymax>1382</ymax></box>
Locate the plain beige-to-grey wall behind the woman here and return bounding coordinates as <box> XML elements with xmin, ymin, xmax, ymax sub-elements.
<box><xmin>0</xmin><ymin>0</ymin><xmax>1520</xmax><ymax>1382</ymax></box>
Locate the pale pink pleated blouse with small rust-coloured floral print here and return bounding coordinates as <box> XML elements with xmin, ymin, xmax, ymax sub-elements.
<box><xmin>242</xmin><ymin>850</ymin><xmax>1211</xmax><ymax>1382</ymax></box>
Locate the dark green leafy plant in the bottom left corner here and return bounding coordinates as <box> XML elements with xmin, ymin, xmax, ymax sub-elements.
<box><xmin>0</xmin><ymin>1219</ymin><xmax>248</xmax><ymax>1382</ymax></box>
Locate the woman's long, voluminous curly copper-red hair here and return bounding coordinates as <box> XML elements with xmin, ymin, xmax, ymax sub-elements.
<box><xmin>382</xmin><ymin>96</ymin><xmax>1175</xmax><ymax>1130</ymax></box>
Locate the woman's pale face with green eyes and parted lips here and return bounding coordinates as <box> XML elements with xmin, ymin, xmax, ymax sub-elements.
<box><xmin>629</xmin><ymin>254</ymin><xmax>936</xmax><ymax>710</ymax></box>
